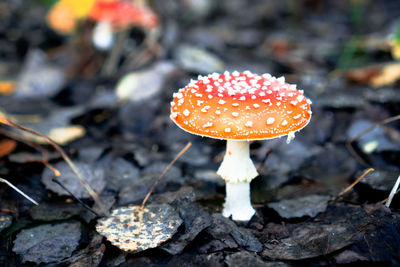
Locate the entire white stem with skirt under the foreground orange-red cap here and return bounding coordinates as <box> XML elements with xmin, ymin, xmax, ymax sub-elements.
<box><xmin>217</xmin><ymin>140</ymin><xmax>258</xmax><ymax>221</ymax></box>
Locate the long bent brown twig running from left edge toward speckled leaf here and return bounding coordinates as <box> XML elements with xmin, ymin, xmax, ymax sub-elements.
<box><xmin>0</xmin><ymin>115</ymin><xmax>105</xmax><ymax>213</ymax></box>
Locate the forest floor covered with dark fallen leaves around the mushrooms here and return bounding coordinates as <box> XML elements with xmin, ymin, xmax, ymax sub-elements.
<box><xmin>0</xmin><ymin>0</ymin><xmax>400</xmax><ymax>266</ymax></box>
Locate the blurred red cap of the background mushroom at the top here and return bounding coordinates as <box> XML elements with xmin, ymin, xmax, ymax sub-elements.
<box><xmin>89</xmin><ymin>0</ymin><xmax>158</xmax><ymax>28</ymax></box>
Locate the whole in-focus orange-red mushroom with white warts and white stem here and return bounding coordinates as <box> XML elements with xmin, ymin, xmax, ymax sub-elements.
<box><xmin>170</xmin><ymin>71</ymin><xmax>311</xmax><ymax>221</ymax></box>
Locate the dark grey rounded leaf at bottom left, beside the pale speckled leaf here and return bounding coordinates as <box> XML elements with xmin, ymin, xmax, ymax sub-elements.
<box><xmin>13</xmin><ymin>222</ymin><xmax>81</xmax><ymax>263</ymax></box>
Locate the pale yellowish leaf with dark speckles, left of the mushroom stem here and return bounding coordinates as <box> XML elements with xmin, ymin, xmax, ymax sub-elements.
<box><xmin>96</xmin><ymin>204</ymin><xmax>182</xmax><ymax>252</ymax></box>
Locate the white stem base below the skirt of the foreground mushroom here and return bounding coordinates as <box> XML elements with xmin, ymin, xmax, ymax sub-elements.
<box><xmin>222</xmin><ymin>182</ymin><xmax>255</xmax><ymax>221</ymax></box>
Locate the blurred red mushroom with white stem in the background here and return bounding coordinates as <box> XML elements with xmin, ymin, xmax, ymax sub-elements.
<box><xmin>89</xmin><ymin>0</ymin><xmax>158</xmax><ymax>50</ymax></box>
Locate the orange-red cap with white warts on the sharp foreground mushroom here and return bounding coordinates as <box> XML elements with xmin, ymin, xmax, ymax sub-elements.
<box><xmin>171</xmin><ymin>71</ymin><xmax>311</xmax><ymax>140</ymax></box>
